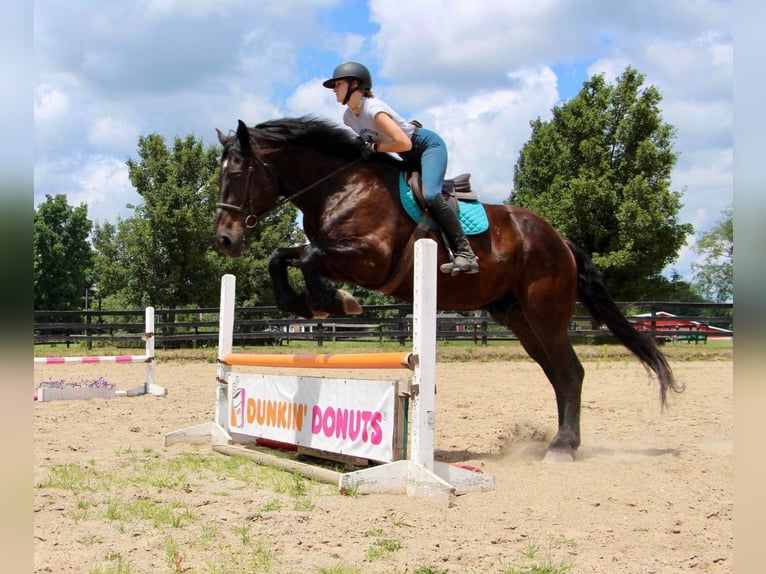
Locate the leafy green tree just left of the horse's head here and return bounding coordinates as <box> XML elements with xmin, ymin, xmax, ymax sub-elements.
<box><xmin>94</xmin><ymin>134</ymin><xmax>224</xmax><ymax>308</ymax></box>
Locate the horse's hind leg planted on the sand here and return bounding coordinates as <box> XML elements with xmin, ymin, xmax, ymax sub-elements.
<box><xmin>490</xmin><ymin>303</ymin><xmax>584</xmax><ymax>460</ymax></box>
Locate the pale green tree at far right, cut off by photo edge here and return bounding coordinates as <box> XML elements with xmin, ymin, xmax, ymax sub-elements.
<box><xmin>692</xmin><ymin>206</ymin><xmax>734</xmax><ymax>303</ymax></box>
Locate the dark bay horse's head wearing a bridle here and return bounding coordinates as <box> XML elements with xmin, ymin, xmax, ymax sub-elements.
<box><xmin>215</xmin><ymin>120</ymin><xmax>279</xmax><ymax>257</ymax></box>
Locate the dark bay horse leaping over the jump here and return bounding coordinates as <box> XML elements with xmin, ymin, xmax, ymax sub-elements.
<box><xmin>215</xmin><ymin>117</ymin><xmax>682</xmax><ymax>459</ymax></box>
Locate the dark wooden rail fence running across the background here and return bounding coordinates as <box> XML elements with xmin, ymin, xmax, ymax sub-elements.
<box><xmin>34</xmin><ymin>301</ymin><xmax>734</xmax><ymax>349</ymax></box>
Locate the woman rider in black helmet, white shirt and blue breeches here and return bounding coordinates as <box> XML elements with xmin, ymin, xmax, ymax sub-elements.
<box><xmin>322</xmin><ymin>62</ymin><xmax>479</xmax><ymax>273</ymax></box>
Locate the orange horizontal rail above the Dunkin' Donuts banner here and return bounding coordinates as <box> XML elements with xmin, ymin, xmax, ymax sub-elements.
<box><xmin>221</xmin><ymin>352</ymin><xmax>415</xmax><ymax>370</ymax></box>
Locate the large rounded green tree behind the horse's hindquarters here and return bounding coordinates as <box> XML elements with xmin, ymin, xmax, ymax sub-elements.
<box><xmin>510</xmin><ymin>67</ymin><xmax>693</xmax><ymax>300</ymax></box>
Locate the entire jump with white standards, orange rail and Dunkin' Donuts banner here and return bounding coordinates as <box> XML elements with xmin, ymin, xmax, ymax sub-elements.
<box><xmin>165</xmin><ymin>239</ymin><xmax>494</xmax><ymax>505</ymax></box>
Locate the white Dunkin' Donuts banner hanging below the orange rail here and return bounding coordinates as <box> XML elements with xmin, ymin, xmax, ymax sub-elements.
<box><xmin>229</xmin><ymin>373</ymin><xmax>396</xmax><ymax>462</ymax></box>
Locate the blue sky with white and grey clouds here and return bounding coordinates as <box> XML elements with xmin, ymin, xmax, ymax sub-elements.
<box><xmin>33</xmin><ymin>0</ymin><xmax>734</xmax><ymax>280</ymax></box>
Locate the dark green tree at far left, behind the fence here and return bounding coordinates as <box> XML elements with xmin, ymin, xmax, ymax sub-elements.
<box><xmin>33</xmin><ymin>195</ymin><xmax>92</xmax><ymax>311</ymax></box>
